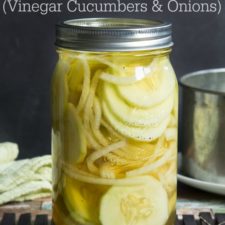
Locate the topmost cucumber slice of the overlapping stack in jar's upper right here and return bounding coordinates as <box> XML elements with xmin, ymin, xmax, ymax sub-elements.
<box><xmin>117</xmin><ymin>58</ymin><xmax>175</xmax><ymax>108</ymax></box>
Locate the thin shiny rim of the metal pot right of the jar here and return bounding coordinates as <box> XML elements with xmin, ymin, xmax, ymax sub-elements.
<box><xmin>178</xmin><ymin>68</ymin><xmax>225</xmax><ymax>95</ymax></box>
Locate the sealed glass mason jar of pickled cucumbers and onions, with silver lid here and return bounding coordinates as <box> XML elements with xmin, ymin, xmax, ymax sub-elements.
<box><xmin>52</xmin><ymin>18</ymin><xmax>178</xmax><ymax>225</ymax></box>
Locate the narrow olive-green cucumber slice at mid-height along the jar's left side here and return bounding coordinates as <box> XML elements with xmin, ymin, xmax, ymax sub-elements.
<box><xmin>64</xmin><ymin>103</ymin><xmax>87</xmax><ymax>165</ymax></box>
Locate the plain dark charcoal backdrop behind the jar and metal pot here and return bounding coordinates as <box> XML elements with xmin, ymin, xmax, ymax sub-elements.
<box><xmin>0</xmin><ymin>0</ymin><xmax>225</xmax><ymax>158</ymax></box>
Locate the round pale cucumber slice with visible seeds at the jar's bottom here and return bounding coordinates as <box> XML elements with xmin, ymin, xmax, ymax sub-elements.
<box><xmin>100</xmin><ymin>176</ymin><xmax>169</xmax><ymax>225</ymax></box>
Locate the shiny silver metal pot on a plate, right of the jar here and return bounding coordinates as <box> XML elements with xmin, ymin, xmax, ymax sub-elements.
<box><xmin>180</xmin><ymin>68</ymin><xmax>225</xmax><ymax>184</ymax></box>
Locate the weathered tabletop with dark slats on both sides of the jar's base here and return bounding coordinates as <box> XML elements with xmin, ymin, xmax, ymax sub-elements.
<box><xmin>0</xmin><ymin>184</ymin><xmax>225</xmax><ymax>225</ymax></box>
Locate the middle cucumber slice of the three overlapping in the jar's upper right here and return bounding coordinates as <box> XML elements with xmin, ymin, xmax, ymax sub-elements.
<box><xmin>103</xmin><ymin>83</ymin><xmax>174</xmax><ymax>127</ymax></box>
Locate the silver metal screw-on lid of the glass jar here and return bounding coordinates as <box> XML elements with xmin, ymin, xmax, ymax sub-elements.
<box><xmin>56</xmin><ymin>18</ymin><xmax>173</xmax><ymax>52</ymax></box>
